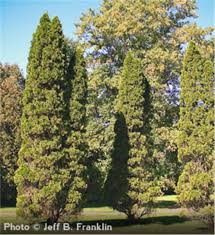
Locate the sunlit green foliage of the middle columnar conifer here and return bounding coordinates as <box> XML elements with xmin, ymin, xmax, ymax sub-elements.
<box><xmin>111</xmin><ymin>52</ymin><xmax>159</xmax><ymax>220</ymax></box>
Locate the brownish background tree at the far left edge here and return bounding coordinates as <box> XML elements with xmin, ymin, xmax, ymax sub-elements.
<box><xmin>0</xmin><ymin>64</ymin><xmax>24</xmax><ymax>206</ymax></box>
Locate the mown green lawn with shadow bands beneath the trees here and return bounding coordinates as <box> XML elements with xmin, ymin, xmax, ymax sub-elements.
<box><xmin>0</xmin><ymin>195</ymin><xmax>213</xmax><ymax>234</ymax></box>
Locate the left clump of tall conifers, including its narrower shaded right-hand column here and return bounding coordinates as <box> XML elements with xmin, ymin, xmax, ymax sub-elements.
<box><xmin>16</xmin><ymin>13</ymin><xmax>87</xmax><ymax>223</ymax></box>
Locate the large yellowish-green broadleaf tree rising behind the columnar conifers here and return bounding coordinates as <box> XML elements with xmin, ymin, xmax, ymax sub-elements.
<box><xmin>77</xmin><ymin>0</ymin><xmax>212</xmax><ymax>191</ymax></box>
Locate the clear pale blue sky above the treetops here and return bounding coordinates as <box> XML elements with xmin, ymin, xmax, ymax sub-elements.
<box><xmin>0</xmin><ymin>0</ymin><xmax>215</xmax><ymax>73</ymax></box>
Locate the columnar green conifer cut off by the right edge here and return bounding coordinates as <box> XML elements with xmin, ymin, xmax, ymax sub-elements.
<box><xmin>177</xmin><ymin>42</ymin><xmax>214</xmax><ymax>228</ymax></box>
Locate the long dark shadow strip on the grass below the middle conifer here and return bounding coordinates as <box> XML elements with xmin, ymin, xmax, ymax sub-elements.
<box><xmin>71</xmin><ymin>216</ymin><xmax>187</xmax><ymax>227</ymax></box>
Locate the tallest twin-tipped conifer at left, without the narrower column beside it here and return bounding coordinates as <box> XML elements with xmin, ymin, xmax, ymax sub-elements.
<box><xmin>15</xmin><ymin>13</ymin><xmax>70</xmax><ymax>223</ymax></box>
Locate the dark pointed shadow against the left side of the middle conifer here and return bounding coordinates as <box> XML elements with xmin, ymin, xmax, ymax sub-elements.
<box><xmin>105</xmin><ymin>112</ymin><xmax>129</xmax><ymax>211</ymax></box>
